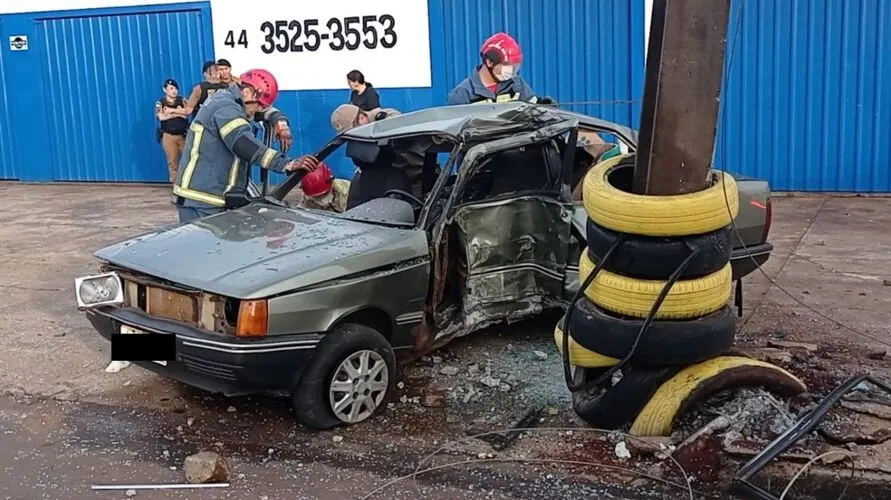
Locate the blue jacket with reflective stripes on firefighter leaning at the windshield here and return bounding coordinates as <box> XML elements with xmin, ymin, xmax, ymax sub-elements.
<box><xmin>173</xmin><ymin>85</ymin><xmax>291</xmax><ymax>207</ymax></box>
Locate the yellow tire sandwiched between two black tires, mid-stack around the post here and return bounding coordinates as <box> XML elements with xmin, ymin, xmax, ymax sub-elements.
<box><xmin>579</xmin><ymin>249</ymin><xmax>733</xmax><ymax>319</ymax></box>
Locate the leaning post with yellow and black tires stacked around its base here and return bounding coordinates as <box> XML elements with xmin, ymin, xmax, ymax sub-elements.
<box><xmin>554</xmin><ymin>0</ymin><xmax>806</xmax><ymax>436</ymax></box>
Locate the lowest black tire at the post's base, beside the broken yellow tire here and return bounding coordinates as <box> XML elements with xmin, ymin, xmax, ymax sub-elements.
<box><xmin>572</xmin><ymin>363</ymin><xmax>684</xmax><ymax>430</ymax></box>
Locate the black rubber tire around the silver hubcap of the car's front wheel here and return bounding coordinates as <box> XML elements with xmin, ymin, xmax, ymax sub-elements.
<box><xmin>291</xmin><ymin>323</ymin><xmax>396</xmax><ymax>429</ymax></box>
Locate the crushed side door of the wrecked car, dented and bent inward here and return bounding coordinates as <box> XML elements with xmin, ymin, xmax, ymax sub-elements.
<box><xmin>440</xmin><ymin>120</ymin><xmax>577</xmax><ymax>330</ymax></box>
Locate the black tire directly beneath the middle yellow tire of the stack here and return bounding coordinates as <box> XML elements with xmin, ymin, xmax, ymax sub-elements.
<box><xmin>569</xmin><ymin>297</ymin><xmax>736</xmax><ymax>365</ymax></box>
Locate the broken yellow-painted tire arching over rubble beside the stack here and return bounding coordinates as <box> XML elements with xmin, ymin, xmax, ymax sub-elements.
<box><xmin>631</xmin><ymin>356</ymin><xmax>807</xmax><ymax>436</ymax></box>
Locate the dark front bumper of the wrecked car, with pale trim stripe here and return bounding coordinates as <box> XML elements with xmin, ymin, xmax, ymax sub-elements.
<box><xmin>86</xmin><ymin>307</ymin><xmax>323</xmax><ymax>396</ymax></box>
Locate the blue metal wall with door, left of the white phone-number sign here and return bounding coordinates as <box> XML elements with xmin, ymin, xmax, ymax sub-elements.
<box><xmin>0</xmin><ymin>2</ymin><xmax>213</xmax><ymax>182</ymax></box>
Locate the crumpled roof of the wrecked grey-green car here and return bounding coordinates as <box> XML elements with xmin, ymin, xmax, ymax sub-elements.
<box><xmin>343</xmin><ymin>101</ymin><xmax>637</xmax><ymax>145</ymax></box>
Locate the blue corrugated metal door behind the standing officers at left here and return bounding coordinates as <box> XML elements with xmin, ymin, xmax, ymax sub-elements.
<box><xmin>37</xmin><ymin>9</ymin><xmax>210</xmax><ymax>182</ymax></box>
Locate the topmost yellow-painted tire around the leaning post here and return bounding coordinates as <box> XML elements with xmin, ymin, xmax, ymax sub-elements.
<box><xmin>582</xmin><ymin>155</ymin><xmax>739</xmax><ymax>237</ymax></box>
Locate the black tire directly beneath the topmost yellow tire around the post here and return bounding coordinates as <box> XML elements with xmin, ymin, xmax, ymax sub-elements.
<box><xmin>586</xmin><ymin>219</ymin><xmax>733</xmax><ymax>280</ymax></box>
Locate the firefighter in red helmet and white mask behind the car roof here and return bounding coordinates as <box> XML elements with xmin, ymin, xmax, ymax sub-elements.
<box><xmin>448</xmin><ymin>33</ymin><xmax>555</xmax><ymax>105</ymax></box>
